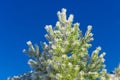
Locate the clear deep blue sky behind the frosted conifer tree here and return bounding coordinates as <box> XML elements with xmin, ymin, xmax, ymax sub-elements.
<box><xmin>0</xmin><ymin>0</ymin><xmax>120</xmax><ymax>80</ymax></box>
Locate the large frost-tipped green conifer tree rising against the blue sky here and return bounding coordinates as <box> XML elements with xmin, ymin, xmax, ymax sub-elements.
<box><xmin>8</xmin><ymin>8</ymin><xmax>120</xmax><ymax>80</ymax></box>
